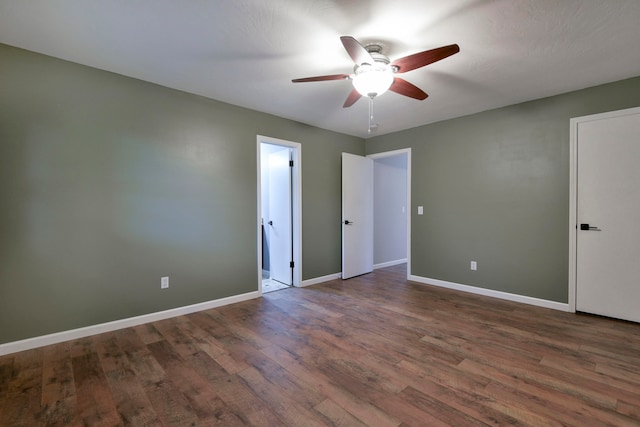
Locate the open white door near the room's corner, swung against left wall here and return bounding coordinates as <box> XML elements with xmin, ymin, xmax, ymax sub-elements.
<box><xmin>342</xmin><ymin>153</ymin><xmax>373</xmax><ymax>279</ymax></box>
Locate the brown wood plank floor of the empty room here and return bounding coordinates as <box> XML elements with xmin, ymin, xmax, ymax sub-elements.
<box><xmin>0</xmin><ymin>266</ymin><xmax>640</xmax><ymax>427</ymax></box>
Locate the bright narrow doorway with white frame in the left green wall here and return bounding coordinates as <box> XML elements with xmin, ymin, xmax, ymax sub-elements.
<box><xmin>257</xmin><ymin>135</ymin><xmax>302</xmax><ymax>293</ymax></box>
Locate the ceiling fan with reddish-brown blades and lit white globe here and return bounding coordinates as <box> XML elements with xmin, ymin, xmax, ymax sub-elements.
<box><xmin>292</xmin><ymin>36</ymin><xmax>460</xmax><ymax>108</ymax></box>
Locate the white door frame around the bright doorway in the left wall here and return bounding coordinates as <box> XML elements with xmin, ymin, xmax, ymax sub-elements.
<box><xmin>256</xmin><ymin>135</ymin><xmax>302</xmax><ymax>294</ymax></box>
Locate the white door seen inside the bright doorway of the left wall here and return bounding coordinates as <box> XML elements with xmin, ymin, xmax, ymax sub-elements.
<box><xmin>266</xmin><ymin>147</ymin><xmax>292</xmax><ymax>285</ymax></box>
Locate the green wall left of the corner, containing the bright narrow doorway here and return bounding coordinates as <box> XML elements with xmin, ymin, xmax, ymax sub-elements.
<box><xmin>0</xmin><ymin>44</ymin><xmax>364</xmax><ymax>343</ymax></box>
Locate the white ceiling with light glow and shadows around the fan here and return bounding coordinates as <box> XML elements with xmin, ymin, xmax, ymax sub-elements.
<box><xmin>0</xmin><ymin>0</ymin><xmax>640</xmax><ymax>138</ymax></box>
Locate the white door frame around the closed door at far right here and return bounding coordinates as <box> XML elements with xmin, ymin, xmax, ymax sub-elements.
<box><xmin>568</xmin><ymin>107</ymin><xmax>640</xmax><ymax>313</ymax></box>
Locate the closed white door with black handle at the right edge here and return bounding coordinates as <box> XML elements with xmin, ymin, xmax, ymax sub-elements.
<box><xmin>576</xmin><ymin>109</ymin><xmax>640</xmax><ymax>322</ymax></box>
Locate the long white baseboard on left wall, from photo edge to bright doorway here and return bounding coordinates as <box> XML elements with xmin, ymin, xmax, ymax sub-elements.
<box><xmin>0</xmin><ymin>291</ymin><xmax>261</xmax><ymax>356</ymax></box>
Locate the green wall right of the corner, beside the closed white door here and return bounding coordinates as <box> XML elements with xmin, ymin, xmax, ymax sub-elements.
<box><xmin>366</xmin><ymin>77</ymin><xmax>640</xmax><ymax>303</ymax></box>
